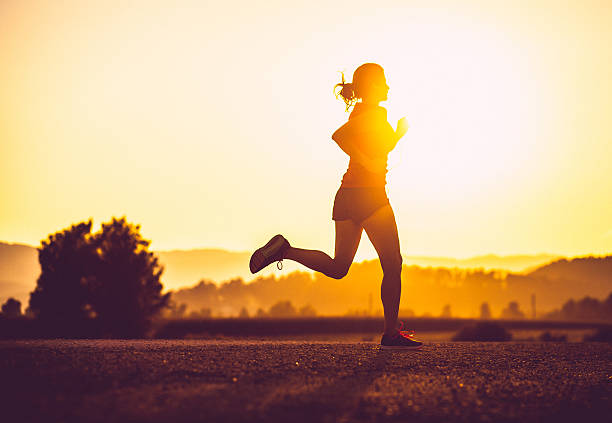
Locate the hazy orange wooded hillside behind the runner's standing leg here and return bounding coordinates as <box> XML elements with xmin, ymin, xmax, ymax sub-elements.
<box><xmin>172</xmin><ymin>256</ymin><xmax>612</xmax><ymax>318</ymax></box>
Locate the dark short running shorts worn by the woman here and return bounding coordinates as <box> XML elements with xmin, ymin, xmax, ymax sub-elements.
<box><xmin>332</xmin><ymin>186</ymin><xmax>389</xmax><ymax>225</ymax></box>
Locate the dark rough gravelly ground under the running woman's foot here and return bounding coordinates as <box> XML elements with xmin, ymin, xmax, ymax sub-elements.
<box><xmin>0</xmin><ymin>340</ymin><xmax>612</xmax><ymax>423</ymax></box>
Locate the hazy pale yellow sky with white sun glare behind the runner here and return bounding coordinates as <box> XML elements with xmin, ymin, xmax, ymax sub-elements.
<box><xmin>0</xmin><ymin>0</ymin><xmax>612</xmax><ymax>259</ymax></box>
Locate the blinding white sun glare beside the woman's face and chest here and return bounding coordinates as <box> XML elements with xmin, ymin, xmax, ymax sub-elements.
<box><xmin>382</xmin><ymin>21</ymin><xmax>542</xmax><ymax>202</ymax></box>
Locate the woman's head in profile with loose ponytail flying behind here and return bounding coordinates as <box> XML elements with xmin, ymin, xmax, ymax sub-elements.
<box><xmin>334</xmin><ymin>63</ymin><xmax>389</xmax><ymax>110</ymax></box>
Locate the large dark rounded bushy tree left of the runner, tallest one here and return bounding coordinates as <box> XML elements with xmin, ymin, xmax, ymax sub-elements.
<box><xmin>30</xmin><ymin>218</ymin><xmax>170</xmax><ymax>337</ymax></box>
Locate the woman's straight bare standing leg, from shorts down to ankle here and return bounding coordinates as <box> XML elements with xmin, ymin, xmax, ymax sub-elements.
<box><xmin>363</xmin><ymin>205</ymin><xmax>402</xmax><ymax>335</ymax></box>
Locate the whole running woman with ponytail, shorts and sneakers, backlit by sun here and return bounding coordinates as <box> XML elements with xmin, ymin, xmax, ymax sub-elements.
<box><xmin>250</xmin><ymin>63</ymin><xmax>422</xmax><ymax>349</ymax></box>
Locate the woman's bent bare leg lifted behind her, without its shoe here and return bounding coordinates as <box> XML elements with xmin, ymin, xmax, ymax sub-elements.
<box><xmin>284</xmin><ymin>220</ymin><xmax>362</xmax><ymax>279</ymax></box>
